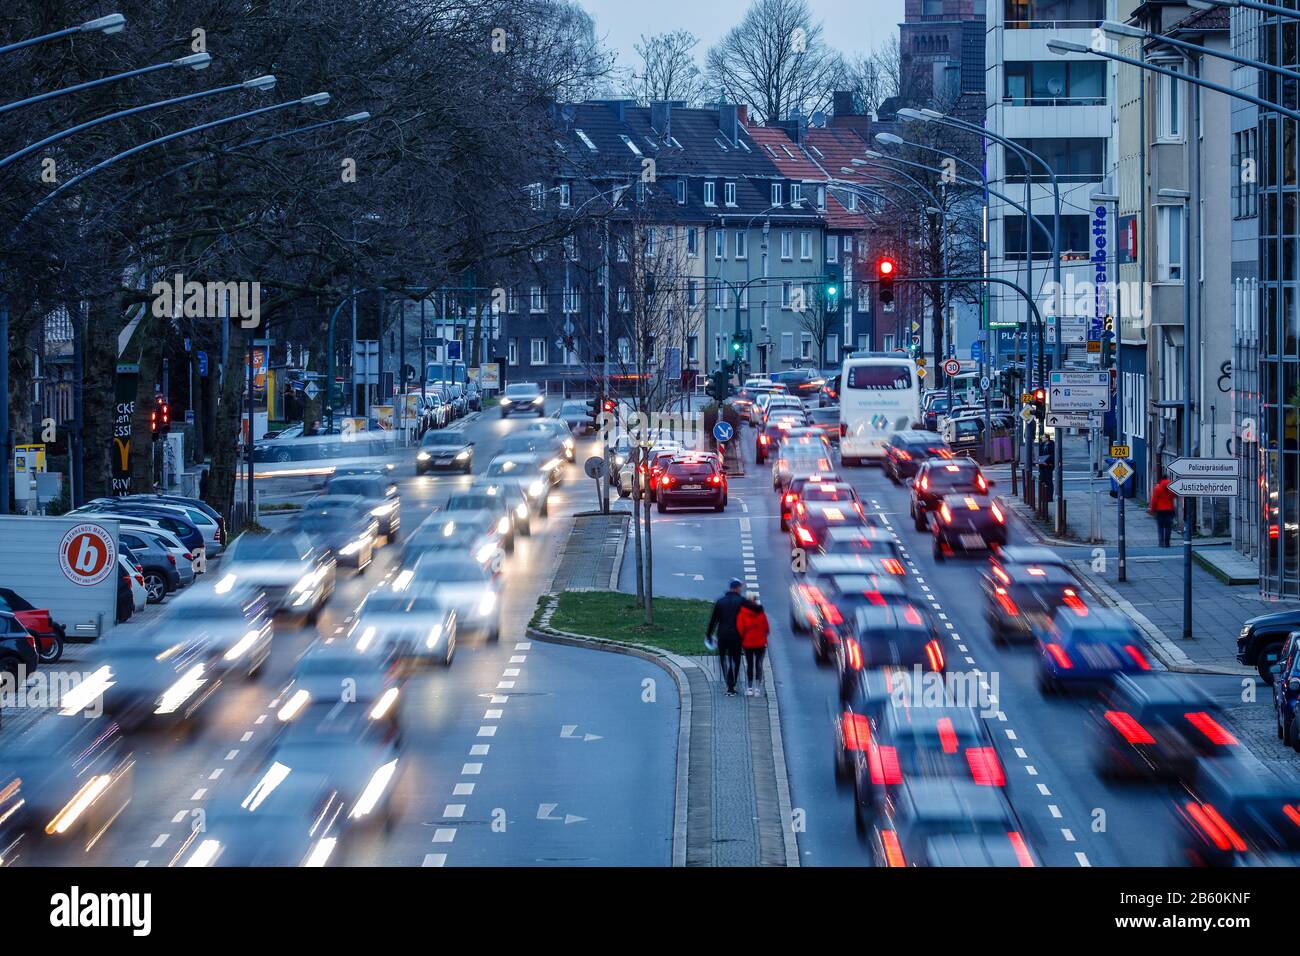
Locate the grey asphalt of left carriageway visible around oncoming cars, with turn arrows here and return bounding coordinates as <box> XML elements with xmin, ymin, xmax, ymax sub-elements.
<box><xmin>10</xmin><ymin>412</ymin><xmax>679</xmax><ymax>866</ymax></box>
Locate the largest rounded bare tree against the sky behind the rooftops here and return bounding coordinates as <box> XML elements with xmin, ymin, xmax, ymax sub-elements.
<box><xmin>706</xmin><ymin>0</ymin><xmax>845</xmax><ymax>122</ymax></box>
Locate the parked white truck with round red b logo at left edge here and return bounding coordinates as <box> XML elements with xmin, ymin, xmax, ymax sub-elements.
<box><xmin>0</xmin><ymin>515</ymin><xmax>122</xmax><ymax>644</ymax></box>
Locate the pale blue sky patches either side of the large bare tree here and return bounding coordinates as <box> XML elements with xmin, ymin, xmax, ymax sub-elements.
<box><xmin>577</xmin><ymin>0</ymin><xmax>904</xmax><ymax>75</ymax></box>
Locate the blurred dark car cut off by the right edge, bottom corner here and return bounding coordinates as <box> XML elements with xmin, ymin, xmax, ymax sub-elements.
<box><xmin>1174</xmin><ymin>761</ymin><xmax>1300</xmax><ymax>866</ymax></box>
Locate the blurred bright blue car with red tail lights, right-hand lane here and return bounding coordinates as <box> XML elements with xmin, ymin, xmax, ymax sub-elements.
<box><xmin>1037</xmin><ymin>606</ymin><xmax>1151</xmax><ymax>693</ymax></box>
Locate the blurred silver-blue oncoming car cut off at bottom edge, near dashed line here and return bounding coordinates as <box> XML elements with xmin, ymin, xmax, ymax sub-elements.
<box><xmin>181</xmin><ymin>762</ymin><xmax>347</xmax><ymax>866</ymax></box>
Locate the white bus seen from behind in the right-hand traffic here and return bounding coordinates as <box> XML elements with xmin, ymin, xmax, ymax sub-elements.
<box><xmin>840</xmin><ymin>352</ymin><xmax>922</xmax><ymax>466</ymax></box>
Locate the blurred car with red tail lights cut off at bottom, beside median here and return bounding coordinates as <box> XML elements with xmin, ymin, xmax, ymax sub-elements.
<box><xmin>859</xmin><ymin>779</ymin><xmax>1039</xmax><ymax>868</ymax></box>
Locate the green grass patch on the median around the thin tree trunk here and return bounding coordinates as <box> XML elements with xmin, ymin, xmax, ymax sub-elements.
<box><xmin>533</xmin><ymin>591</ymin><xmax>714</xmax><ymax>656</ymax></box>
